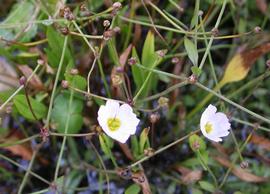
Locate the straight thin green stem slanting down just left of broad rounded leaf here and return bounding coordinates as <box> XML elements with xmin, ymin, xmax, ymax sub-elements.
<box><xmin>45</xmin><ymin>36</ymin><xmax>68</xmax><ymax>128</ymax></box>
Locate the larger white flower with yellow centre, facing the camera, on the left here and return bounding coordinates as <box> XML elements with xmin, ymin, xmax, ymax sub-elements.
<box><xmin>97</xmin><ymin>100</ymin><xmax>140</xmax><ymax>143</ymax></box>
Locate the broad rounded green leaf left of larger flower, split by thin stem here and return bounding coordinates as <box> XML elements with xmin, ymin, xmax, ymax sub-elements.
<box><xmin>52</xmin><ymin>94</ymin><xmax>83</xmax><ymax>133</ymax></box>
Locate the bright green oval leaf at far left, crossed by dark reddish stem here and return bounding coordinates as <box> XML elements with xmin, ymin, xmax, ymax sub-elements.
<box><xmin>13</xmin><ymin>94</ymin><xmax>47</xmax><ymax>120</ymax></box>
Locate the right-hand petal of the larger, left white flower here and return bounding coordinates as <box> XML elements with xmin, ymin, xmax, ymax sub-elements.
<box><xmin>118</xmin><ymin>104</ymin><xmax>140</xmax><ymax>135</ymax></box>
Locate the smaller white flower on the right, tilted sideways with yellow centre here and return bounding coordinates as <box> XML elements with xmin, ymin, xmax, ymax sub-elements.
<box><xmin>200</xmin><ymin>104</ymin><xmax>231</xmax><ymax>142</ymax></box>
